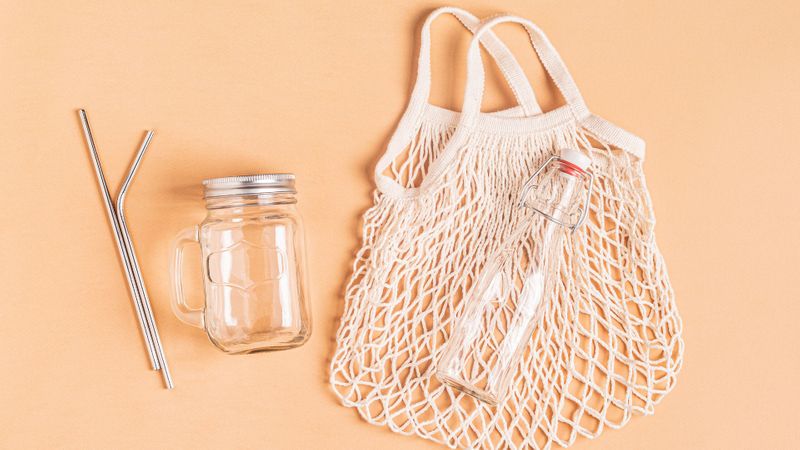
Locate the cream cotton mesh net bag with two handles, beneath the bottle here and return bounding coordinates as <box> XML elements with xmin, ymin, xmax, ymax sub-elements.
<box><xmin>330</xmin><ymin>8</ymin><xmax>683</xmax><ymax>448</ymax></box>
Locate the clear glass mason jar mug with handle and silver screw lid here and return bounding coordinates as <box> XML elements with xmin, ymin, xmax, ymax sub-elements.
<box><xmin>171</xmin><ymin>174</ymin><xmax>311</xmax><ymax>354</ymax></box>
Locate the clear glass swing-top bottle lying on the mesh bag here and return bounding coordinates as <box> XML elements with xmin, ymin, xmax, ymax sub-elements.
<box><xmin>436</xmin><ymin>149</ymin><xmax>594</xmax><ymax>405</ymax></box>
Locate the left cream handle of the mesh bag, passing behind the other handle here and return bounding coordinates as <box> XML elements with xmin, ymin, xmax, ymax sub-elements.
<box><xmin>375</xmin><ymin>7</ymin><xmax>542</xmax><ymax>194</ymax></box>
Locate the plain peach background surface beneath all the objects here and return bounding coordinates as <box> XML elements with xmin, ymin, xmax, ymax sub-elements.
<box><xmin>0</xmin><ymin>0</ymin><xmax>800</xmax><ymax>449</ymax></box>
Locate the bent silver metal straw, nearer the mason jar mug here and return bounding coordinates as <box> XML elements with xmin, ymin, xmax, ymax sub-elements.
<box><xmin>117</xmin><ymin>130</ymin><xmax>173</xmax><ymax>389</ymax></box>
